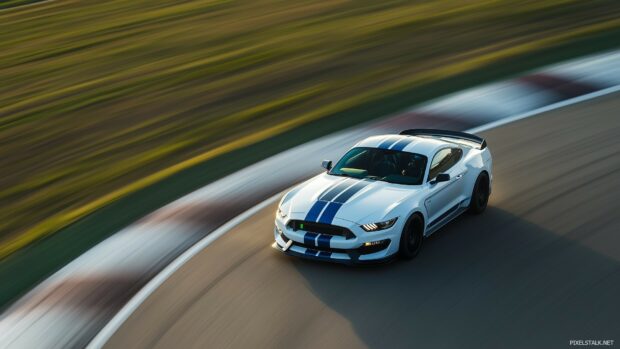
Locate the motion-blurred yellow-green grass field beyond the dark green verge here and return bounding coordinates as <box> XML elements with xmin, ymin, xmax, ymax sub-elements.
<box><xmin>0</xmin><ymin>0</ymin><xmax>620</xmax><ymax>258</ymax></box>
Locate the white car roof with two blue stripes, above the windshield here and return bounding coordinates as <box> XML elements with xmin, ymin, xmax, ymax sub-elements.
<box><xmin>355</xmin><ymin>134</ymin><xmax>460</xmax><ymax>157</ymax></box>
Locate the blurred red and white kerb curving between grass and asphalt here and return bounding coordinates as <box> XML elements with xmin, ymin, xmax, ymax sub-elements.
<box><xmin>0</xmin><ymin>51</ymin><xmax>620</xmax><ymax>348</ymax></box>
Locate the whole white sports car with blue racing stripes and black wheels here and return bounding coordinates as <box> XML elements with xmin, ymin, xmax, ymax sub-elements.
<box><xmin>272</xmin><ymin>129</ymin><xmax>493</xmax><ymax>263</ymax></box>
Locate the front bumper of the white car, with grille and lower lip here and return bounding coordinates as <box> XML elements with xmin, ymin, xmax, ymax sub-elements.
<box><xmin>272</xmin><ymin>219</ymin><xmax>401</xmax><ymax>264</ymax></box>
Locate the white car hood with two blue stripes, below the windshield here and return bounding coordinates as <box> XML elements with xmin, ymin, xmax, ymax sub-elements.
<box><xmin>284</xmin><ymin>173</ymin><xmax>419</xmax><ymax>224</ymax></box>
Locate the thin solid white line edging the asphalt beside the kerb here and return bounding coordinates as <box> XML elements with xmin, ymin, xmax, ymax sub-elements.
<box><xmin>87</xmin><ymin>85</ymin><xmax>620</xmax><ymax>349</ymax></box>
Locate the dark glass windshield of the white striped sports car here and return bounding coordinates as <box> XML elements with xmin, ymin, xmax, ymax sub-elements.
<box><xmin>328</xmin><ymin>147</ymin><xmax>427</xmax><ymax>185</ymax></box>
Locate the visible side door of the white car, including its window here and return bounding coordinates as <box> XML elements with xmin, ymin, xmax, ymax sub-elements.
<box><xmin>424</xmin><ymin>147</ymin><xmax>466</xmax><ymax>226</ymax></box>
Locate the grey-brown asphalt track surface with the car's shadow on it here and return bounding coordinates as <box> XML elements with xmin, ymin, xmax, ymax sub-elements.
<box><xmin>108</xmin><ymin>94</ymin><xmax>620</xmax><ymax>348</ymax></box>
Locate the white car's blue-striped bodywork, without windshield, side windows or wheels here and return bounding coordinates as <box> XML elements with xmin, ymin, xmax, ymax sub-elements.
<box><xmin>272</xmin><ymin>130</ymin><xmax>493</xmax><ymax>263</ymax></box>
